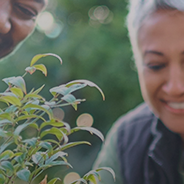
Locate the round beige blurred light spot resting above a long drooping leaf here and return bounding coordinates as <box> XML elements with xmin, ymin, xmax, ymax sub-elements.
<box><xmin>77</xmin><ymin>113</ymin><xmax>94</xmax><ymax>127</ymax></box>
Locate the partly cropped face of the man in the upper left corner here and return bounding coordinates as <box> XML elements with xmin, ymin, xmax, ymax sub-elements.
<box><xmin>0</xmin><ymin>0</ymin><xmax>46</xmax><ymax>58</ymax></box>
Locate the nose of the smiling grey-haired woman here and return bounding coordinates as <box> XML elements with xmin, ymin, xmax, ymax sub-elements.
<box><xmin>163</xmin><ymin>69</ymin><xmax>184</xmax><ymax>96</ymax></box>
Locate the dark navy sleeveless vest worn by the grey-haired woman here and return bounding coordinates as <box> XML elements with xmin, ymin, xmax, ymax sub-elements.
<box><xmin>117</xmin><ymin>104</ymin><xmax>181</xmax><ymax>184</ymax></box>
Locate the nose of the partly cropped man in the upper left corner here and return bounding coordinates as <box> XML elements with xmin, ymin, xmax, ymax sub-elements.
<box><xmin>0</xmin><ymin>1</ymin><xmax>11</xmax><ymax>34</ymax></box>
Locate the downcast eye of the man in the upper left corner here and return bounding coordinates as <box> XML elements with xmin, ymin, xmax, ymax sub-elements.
<box><xmin>16</xmin><ymin>4</ymin><xmax>37</xmax><ymax>19</ymax></box>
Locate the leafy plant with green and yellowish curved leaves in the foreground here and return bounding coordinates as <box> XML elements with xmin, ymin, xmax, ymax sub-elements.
<box><xmin>0</xmin><ymin>53</ymin><xmax>113</xmax><ymax>184</ymax></box>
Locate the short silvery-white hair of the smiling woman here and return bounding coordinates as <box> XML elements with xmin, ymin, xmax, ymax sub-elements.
<box><xmin>127</xmin><ymin>0</ymin><xmax>184</xmax><ymax>64</ymax></box>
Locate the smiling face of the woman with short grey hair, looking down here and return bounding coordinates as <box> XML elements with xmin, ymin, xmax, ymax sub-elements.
<box><xmin>138</xmin><ymin>10</ymin><xmax>184</xmax><ymax>135</ymax></box>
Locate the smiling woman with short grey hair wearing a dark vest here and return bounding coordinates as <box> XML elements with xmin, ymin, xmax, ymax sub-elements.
<box><xmin>95</xmin><ymin>0</ymin><xmax>184</xmax><ymax>184</ymax></box>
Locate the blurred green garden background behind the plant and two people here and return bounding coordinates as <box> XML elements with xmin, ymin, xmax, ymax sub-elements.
<box><xmin>0</xmin><ymin>0</ymin><xmax>142</xmax><ymax>182</ymax></box>
